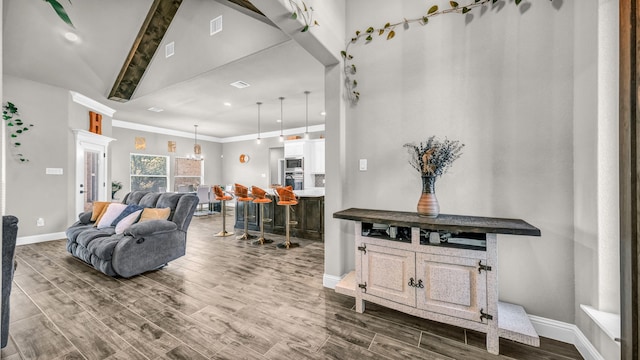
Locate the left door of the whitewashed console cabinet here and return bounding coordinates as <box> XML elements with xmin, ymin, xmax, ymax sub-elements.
<box><xmin>362</xmin><ymin>244</ymin><xmax>416</xmax><ymax>306</ymax></box>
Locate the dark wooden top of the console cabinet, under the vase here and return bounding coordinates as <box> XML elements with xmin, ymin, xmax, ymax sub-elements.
<box><xmin>333</xmin><ymin>208</ymin><xmax>540</xmax><ymax>236</ymax></box>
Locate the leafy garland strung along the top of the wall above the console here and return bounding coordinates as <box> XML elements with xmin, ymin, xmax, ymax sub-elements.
<box><xmin>340</xmin><ymin>0</ymin><xmax>553</xmax><ymax>103</ymax></box>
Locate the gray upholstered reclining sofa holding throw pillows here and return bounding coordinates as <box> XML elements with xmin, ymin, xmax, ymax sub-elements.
<box><xmin>66</xmin><ymin>191</ymin><xmax>198</xmax><ymax>278</ymax></box>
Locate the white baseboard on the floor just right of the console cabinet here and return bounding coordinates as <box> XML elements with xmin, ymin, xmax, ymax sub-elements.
<box><xmin>529</xmin><ymin>315</ymin><xmax>604</xmax><ymax>360</ymax></box>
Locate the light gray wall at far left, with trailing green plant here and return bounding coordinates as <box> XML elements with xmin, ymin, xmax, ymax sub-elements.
<box><xmin>3</xmin><ymin>75</ymin><xmax>74</xmax><ymax>236</ymax></box>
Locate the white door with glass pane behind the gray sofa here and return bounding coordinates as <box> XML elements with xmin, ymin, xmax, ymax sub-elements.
<box><xmin>74</xmin><ymin>130</ymin><xmax>113</xmax><ymax>214</ymax></box>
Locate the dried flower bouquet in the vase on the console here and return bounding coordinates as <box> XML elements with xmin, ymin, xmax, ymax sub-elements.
<box><xmin>404</xmin><ymin>136</ymin><xmax>464</xmax><ymax>177</ymax></box>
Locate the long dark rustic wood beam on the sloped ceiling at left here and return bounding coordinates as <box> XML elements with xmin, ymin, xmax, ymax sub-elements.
<box><xmin>109</xmin><ymin>0</ymin><xmax>182</xmax><ymax>102</ymax></box>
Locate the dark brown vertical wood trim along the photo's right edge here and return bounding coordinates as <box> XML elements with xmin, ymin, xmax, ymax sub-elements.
<box><xmin>619</xmin><ymin>0</ymin><xmax>640</xmax><ymax>360</ymax></box>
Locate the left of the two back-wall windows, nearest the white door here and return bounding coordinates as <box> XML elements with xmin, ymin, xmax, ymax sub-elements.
<box><xmin>130</xmin><ymin>154</ymin><xmax>169</xmax><ymax>192</ymax></box>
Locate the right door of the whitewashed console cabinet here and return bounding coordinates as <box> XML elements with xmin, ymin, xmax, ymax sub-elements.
<box><xmin>416</xmin><ymin>253</ymin><xmax>487</xmax><ymax>322</ymax></box>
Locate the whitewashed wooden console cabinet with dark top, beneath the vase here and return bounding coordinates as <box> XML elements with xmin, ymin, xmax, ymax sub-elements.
<box><xmin>334</xmin><ymin>209</ymin><xmax>540</xmax><ymax>354</ymax></box>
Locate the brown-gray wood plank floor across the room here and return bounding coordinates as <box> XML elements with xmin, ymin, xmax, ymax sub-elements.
<box><xmin>1</xmin><ymin>211</ymin><xmax>581</xmax><ymax>360</ymax></box>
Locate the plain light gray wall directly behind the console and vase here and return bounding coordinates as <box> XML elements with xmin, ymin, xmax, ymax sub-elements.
<box><xmin>344</xmin><ymin>0</ymin><xmax>574</xmax><ymax>323</ymax></box>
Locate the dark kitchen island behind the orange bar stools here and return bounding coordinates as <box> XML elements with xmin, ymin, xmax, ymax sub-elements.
<box><xmin>234</xmin><ymin>189</ymin><xmax>324</xmax><ymax>240</ymax></box>
